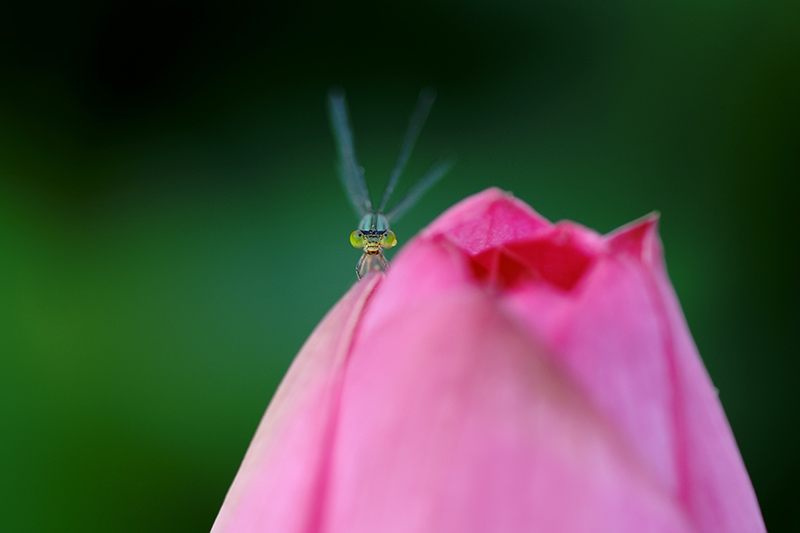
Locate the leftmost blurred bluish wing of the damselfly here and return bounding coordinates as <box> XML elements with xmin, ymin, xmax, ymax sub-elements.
<box><xmin>328</xmin><ymin>89</ymin><xmax>372</xmax><ymax>217</ymax></box>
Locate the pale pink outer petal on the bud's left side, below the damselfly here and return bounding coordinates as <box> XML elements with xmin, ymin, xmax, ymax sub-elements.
<box><xmin>211</xmin><ymin>275</ymin><xmax>383</xmax><ymax>533</ymax></box>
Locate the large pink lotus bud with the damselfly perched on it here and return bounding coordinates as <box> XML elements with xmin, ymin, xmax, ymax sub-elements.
<box><xmin>213</xmin><ymin>189</ymin><xmax>764</xmax><ymax>533</ymax></box>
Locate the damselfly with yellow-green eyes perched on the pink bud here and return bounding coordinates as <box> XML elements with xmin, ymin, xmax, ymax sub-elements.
<box><xmin>328</xmin><ymin>89</ymin><xmax>452</xmax><ymax>280</ymax></box>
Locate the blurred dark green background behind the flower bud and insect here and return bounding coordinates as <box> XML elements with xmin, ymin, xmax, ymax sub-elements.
<box><xmin>0</xmin><ymin>0</ymin><xmax>800</xmax><ymax>532</ymax></box>
